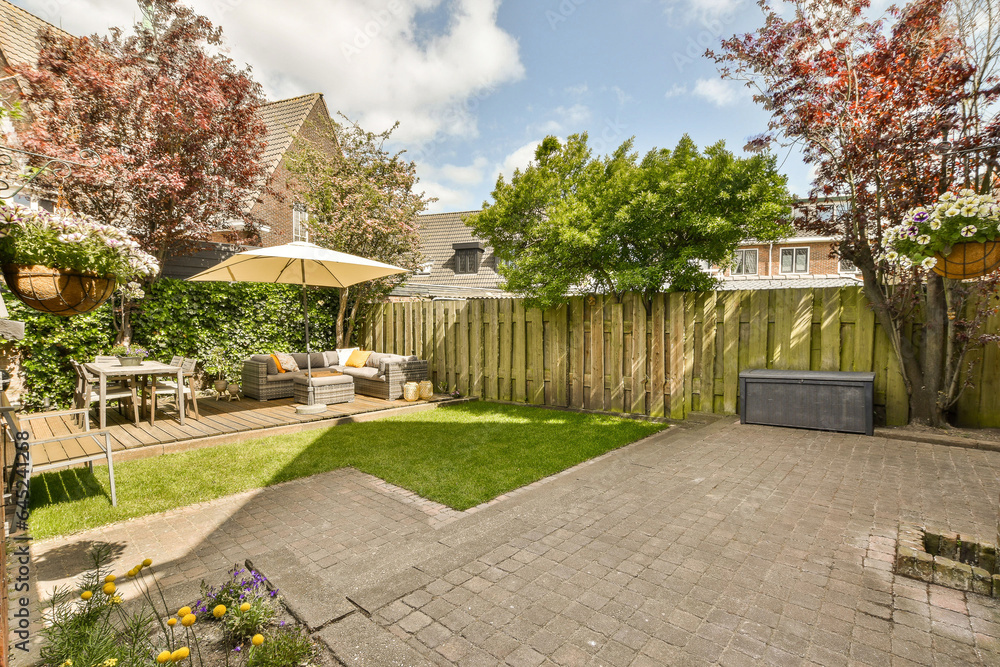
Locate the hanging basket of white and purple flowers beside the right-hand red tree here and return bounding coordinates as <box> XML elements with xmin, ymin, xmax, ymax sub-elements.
<box><xmin>885</xmin><ymin>189</ymin><xmax>1000</xmax><ymax>280</ymax></box>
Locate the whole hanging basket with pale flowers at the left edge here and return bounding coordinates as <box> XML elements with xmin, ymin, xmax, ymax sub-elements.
<box><xmin>0</xmin><ymin>203</ymin><xmax>159</xmax><ymax>316</ymax></box>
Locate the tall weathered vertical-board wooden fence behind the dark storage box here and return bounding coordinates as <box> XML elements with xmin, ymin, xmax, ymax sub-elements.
<box><xmin>365</xmin><ymin>287</ymin><xmax>1000</xmax><ymax>426</ymax></box>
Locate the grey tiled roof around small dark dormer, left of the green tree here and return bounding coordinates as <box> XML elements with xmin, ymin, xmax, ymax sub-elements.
<box><xmin>394</xmin><ymin>211</ymin><xmax>503</xmax><ymax>296</ymax></box>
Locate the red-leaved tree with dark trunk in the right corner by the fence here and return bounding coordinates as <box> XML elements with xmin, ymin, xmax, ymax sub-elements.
<box><xmin>708</xmin><ymin>0</ymin><xmax>1000</xmax><ymax>425</ymax></box>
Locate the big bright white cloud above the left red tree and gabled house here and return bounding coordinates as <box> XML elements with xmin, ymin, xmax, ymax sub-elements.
<box><xmin>19</xmin><ymin>0</ymin><xmax>524</xmax><ymax>144</ymax></box>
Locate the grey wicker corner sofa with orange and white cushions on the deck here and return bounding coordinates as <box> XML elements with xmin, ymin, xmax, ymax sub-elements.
<box><xmin>242</xmin><ymin>350</ymin><xmax>427</xmax><ymax>401</ymax></box>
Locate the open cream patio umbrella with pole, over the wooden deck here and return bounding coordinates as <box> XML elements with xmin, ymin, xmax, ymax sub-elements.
<box><xmin>188</xmin><ymin>241</ymin><xmax>407</xmax><ymax>405</ymax></box>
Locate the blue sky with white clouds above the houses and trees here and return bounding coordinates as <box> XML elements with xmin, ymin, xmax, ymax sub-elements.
<box><xmin>14</xmin><ymin>0</ymin><xmax>852</xmax><ymax>211</ymax></box>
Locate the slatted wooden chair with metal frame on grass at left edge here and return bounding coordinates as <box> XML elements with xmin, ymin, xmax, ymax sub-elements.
<box><xmin>0</xmin><ymin>392</ymin><xmax>118</xmax><ymax>506</ymax></box>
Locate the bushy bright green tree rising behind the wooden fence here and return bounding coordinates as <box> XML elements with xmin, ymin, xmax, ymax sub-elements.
<box><xmin>466</xmin><ymin>134</ymin><xmax>790</xmax><ymax>307</ymax></box>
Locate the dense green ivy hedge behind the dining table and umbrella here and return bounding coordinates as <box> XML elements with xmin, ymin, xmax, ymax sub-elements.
<box><xmin>4</xmin><ymin>278</ymin><xmax>339</xmax><ymax>410</ymax></box>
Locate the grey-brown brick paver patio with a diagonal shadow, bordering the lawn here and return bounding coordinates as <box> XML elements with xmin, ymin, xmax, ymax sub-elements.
<box><xmin>29</xmin><ymin>420</ymin><xmax>1000</xmax><ymax>667</ymax></box>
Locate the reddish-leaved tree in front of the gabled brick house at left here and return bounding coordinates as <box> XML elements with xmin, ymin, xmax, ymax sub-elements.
<box><xmin>17</xmin><ymin>0</ymin><xmax>266</xmax><ymax>272</ymax></box>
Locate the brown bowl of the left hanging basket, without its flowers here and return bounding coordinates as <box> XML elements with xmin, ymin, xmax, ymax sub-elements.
<box><xmin>3</xmin><ymin>264</ymin><xmax>116</xmax><ymax>317</ymax></box>
